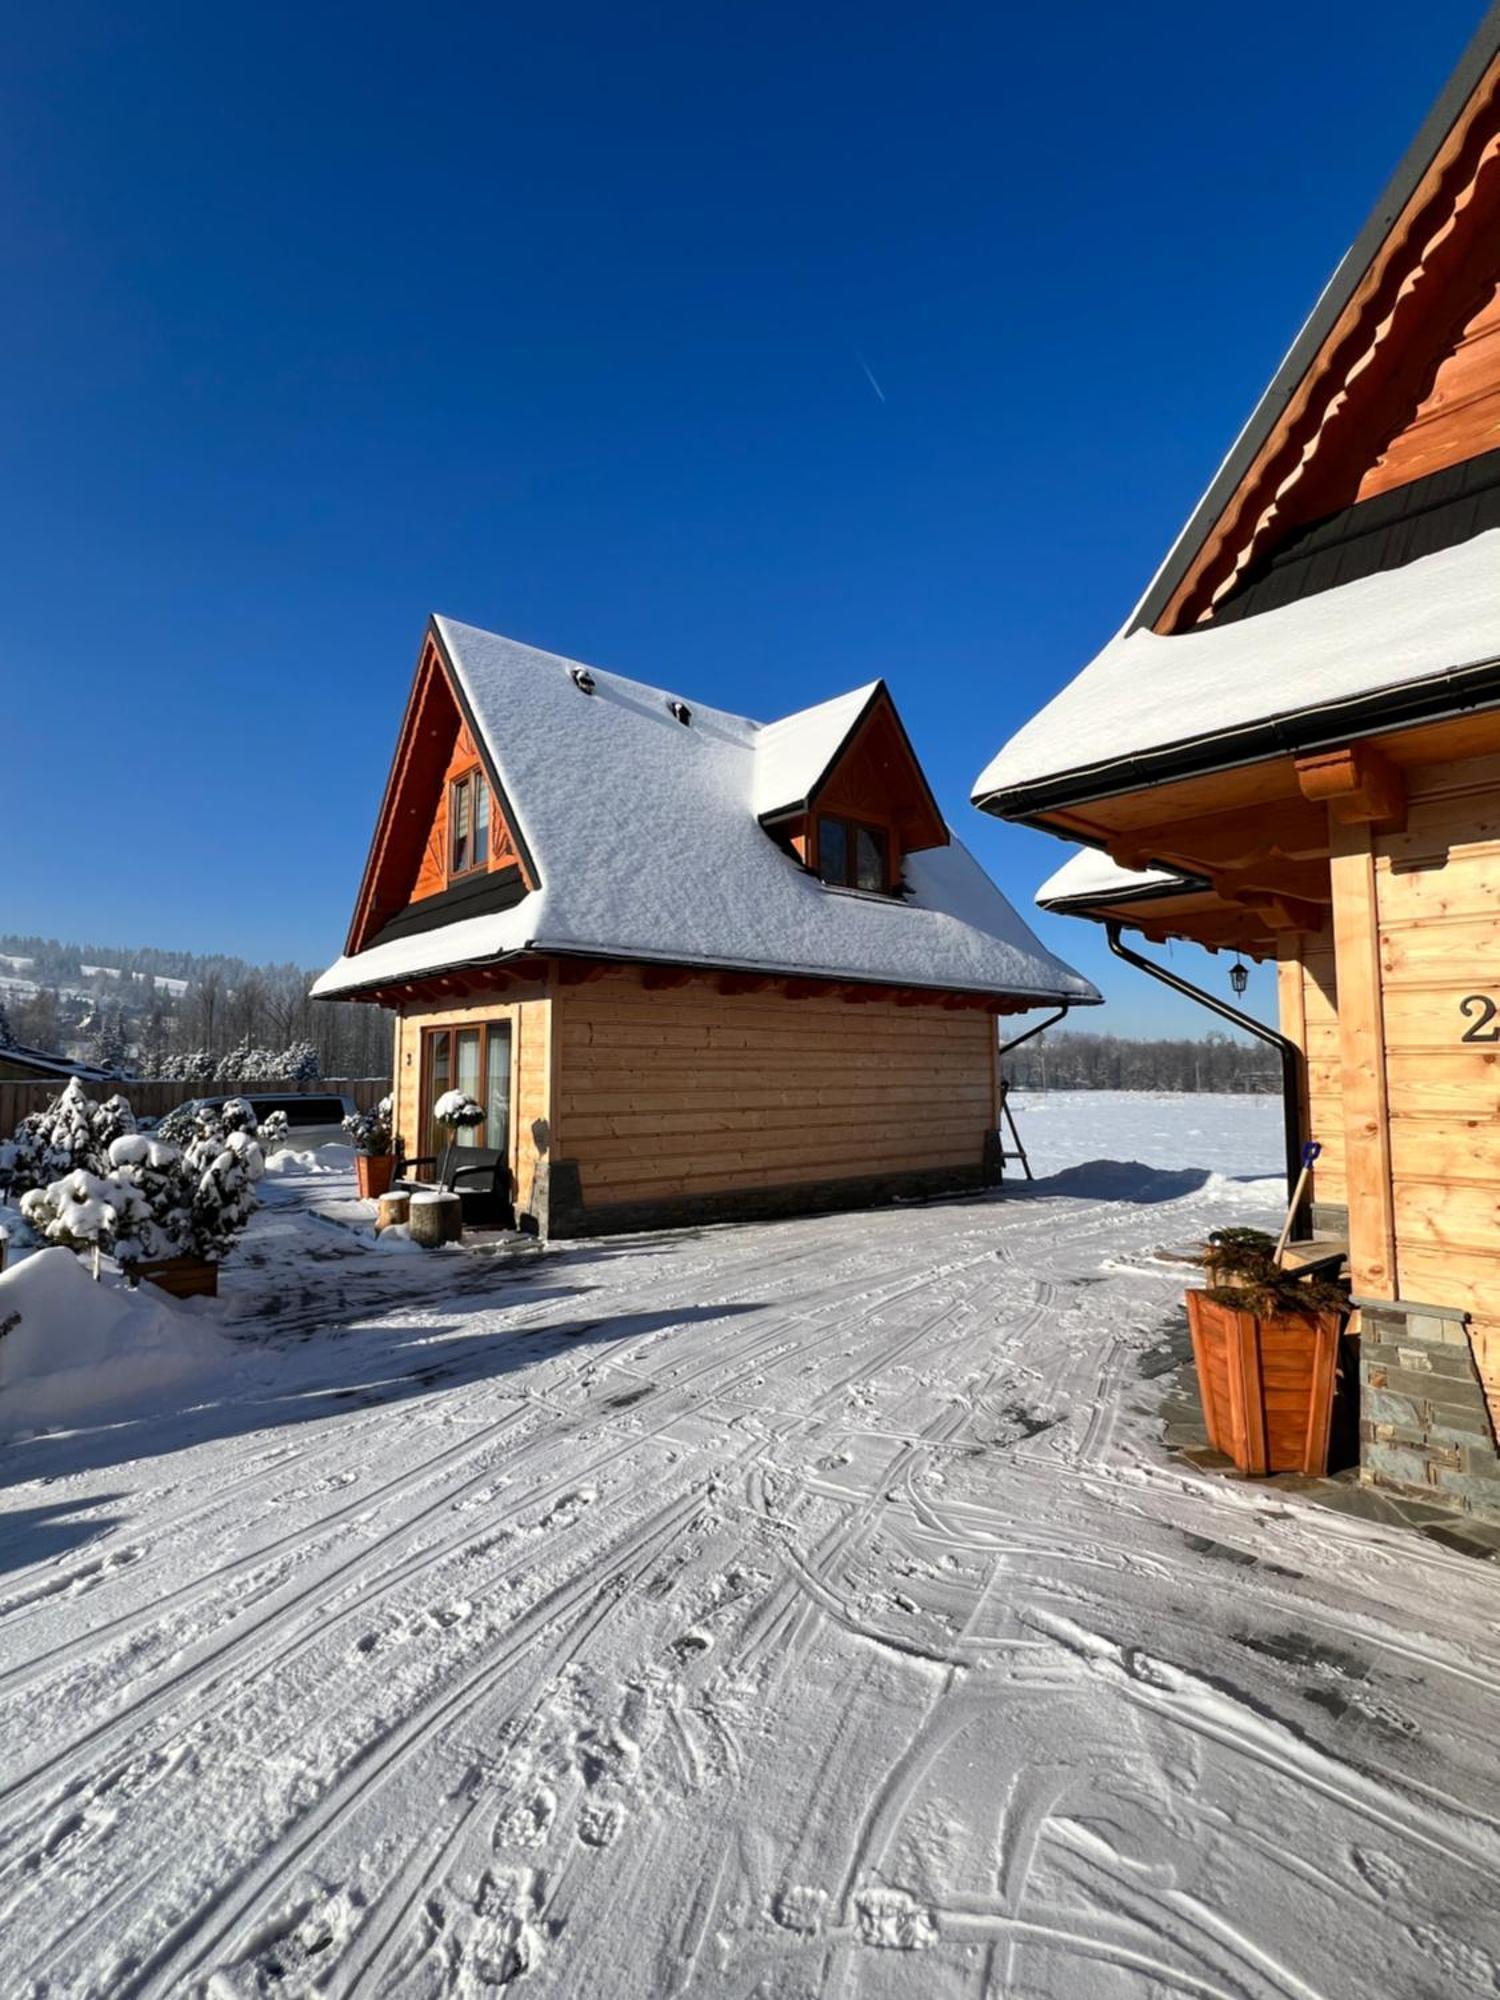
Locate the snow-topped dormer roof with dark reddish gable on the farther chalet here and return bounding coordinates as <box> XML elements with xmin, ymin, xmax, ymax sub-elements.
<box><xmin>756</xmin><ymin>680</ymin><xmax>950</xmax><ymax>854</ymax></box>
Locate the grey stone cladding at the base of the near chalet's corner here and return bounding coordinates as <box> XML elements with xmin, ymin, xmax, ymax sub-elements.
<box><xmin>1360</xmin><ymin>1304</ymin><xmax>1500</xmax><ymax>1522</ymax></box>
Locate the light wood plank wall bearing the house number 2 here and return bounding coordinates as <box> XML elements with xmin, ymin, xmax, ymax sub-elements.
<box><xmin>1376</xmin><ymin>756</ymin><xmax>1500</xmax><ymax>1416</ymax></box>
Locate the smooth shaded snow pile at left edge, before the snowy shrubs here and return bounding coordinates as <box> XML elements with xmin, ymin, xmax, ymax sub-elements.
<box><xmin>0</xmin><ymin>1248</ymin><xmax>230</xmax><ymax>1436</ymax></box>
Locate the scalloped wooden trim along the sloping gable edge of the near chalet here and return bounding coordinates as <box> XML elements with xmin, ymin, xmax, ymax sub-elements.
<box><xmin>1128</xmin><ymin>0</ymin><xmax>1500</xmax><ymax>632</ymax></box>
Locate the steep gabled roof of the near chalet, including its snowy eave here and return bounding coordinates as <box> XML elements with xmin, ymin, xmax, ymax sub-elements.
<box><xmin>974</xmin><ymin>0</ymin><xmax>1500</xmax><ymax>816</ymax></box>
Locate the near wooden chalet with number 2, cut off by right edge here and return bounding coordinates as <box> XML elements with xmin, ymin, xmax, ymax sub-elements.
<box><xmin>974</xmin><ymin>6</ymin><xmax>1500</xmax><ymax>1510</ymax></box>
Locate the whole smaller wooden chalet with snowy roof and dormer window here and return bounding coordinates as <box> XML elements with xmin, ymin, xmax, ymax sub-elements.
<box><xmin>314</xmin><ymin>618</ymin><xmax>1098</xmax><ymax>1236</ymax></box>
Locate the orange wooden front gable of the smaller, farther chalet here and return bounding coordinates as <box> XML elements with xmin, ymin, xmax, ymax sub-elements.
<box><xmin>344</xmin><ymin>630</ymin><xmax>538</xmax><ymax>952</ymax></box>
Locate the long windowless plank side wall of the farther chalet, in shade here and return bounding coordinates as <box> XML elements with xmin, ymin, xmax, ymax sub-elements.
<box><xmin>554</xmin><ymin>974</ymin><xmax>996</xmax><ymax>1204</ymax></box>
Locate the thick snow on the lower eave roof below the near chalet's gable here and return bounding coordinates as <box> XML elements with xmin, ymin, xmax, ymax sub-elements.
<box><xmin>974</xmin><ymin>528</ymin><xmax>1500</xmax><ymax>802</ymax></box>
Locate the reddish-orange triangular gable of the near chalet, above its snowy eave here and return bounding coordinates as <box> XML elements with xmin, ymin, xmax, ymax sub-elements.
<box><xmin>1132</xmin><ymin>4</ymin><xmax>1500</xmax><ymax>634</ymax></box>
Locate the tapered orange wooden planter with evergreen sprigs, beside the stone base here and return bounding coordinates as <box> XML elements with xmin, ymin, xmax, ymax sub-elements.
<box><xmin>1188</xmin><ymin>1230</ymin><xmax>1348</xmax><ymax>1474</ymax></box>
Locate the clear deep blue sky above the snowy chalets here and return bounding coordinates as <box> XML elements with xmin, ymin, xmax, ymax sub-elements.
<box><xmin>0</xmin><ymin>0</ymin><xmax>1480</xmax><ymax>1032</ymax></box>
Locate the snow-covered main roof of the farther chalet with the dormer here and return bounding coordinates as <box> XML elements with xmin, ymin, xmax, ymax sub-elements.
<box><xmin>314</xmin><ymin>618</ymin><xmax>1098</xmax><ymax>1004</ymax></box>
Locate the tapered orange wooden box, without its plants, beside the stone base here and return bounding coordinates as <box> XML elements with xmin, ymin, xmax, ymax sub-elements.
<box><xmin>1188</xmin><ymin>1292</ymin><xmax>1342</xmax><ymax>1476</ymax></box>
